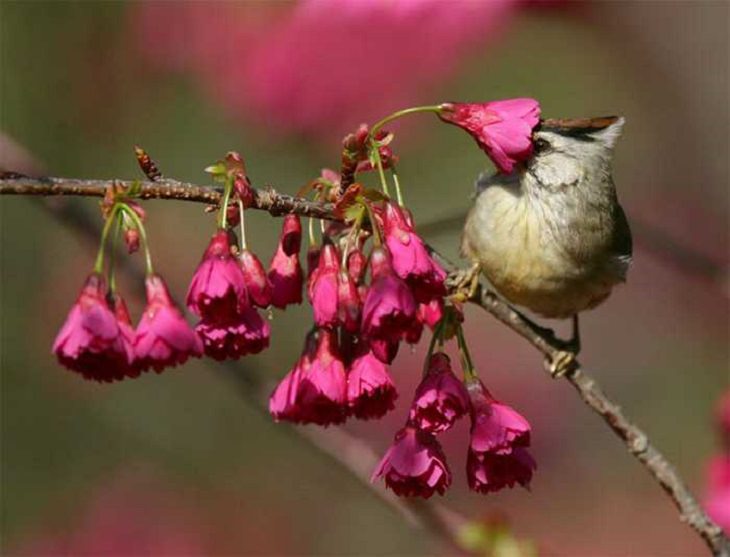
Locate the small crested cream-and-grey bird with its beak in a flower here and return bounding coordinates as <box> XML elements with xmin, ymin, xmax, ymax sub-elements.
<box><xmin>461</xmin><ymin>116</ymin><xmax>632</xmax><ymax>374</ymax></box>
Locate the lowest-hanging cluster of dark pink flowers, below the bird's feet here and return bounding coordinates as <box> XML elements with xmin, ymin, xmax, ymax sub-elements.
<box><xmin>373</xmin><ymin>352</ymin><xmax>536</xmax><ymax>497</ymax></box>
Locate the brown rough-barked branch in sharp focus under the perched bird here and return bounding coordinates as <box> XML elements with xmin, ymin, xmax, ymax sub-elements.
<box><xmin>0</xmin><ymin>176</ymin><xmax>730</xmax><ymax>557</ymax></box>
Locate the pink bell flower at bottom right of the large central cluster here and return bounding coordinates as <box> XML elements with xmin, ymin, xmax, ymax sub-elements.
<box><xmin>347</xmin><ymin>344</ymin><xmax>398</xmax><ymax>420</ymax></box>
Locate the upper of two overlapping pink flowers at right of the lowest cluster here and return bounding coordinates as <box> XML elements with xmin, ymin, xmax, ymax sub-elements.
<box><xmin>468</xmin><ymin>380</ymin><xmax>530</xmax><ymax>454</ymax></box>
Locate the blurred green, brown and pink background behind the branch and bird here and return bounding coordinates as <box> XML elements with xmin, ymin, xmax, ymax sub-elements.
<box><xmin>0</xmin><ymin>0</ymin><xmax>730</xmax><ymax>557</ymax></box>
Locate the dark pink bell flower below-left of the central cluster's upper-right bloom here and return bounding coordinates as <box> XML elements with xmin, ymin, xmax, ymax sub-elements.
<box><xmin>362</xmin><ymin>248</ymin><xmax>417</xmax><ymax>356</ymax></box>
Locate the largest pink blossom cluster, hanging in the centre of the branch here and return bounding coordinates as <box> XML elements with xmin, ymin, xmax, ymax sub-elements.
<box><xmin>269</xmin><ymin>198</ymin><xmax>446</xmax><ymax>425</ymax></box>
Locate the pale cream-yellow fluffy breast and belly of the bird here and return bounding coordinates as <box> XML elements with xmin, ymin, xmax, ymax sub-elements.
<box><xmin>462</xmin><ymin>187</ymin><xmax>618</xmax><ymax>317</ymax></box>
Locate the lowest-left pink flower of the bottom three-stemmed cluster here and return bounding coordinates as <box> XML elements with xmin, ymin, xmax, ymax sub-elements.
<box><xmin>371</xmin><ymin>425</ymin><xmax>451</xmax><ymax>498</ymax></box>
